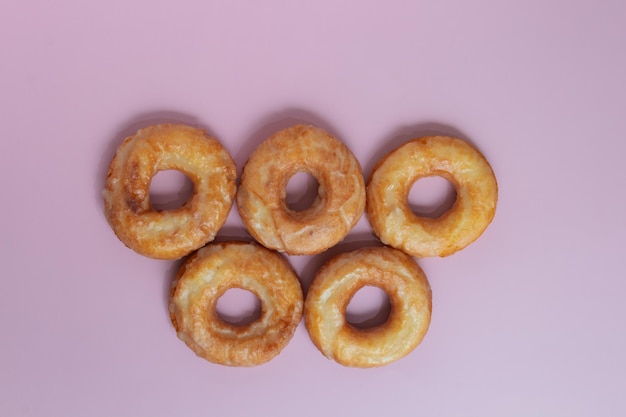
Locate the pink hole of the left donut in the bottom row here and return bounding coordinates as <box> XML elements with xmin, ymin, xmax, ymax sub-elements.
<box><xmin>215</xmin><ymin>288</ymin><xmax>261</xmax><ymax>326</ymax></box>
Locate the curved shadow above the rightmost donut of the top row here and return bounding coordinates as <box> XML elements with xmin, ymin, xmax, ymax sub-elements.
<box><xmin>362</xmin><ymin>121</ymin><xmax>476</xmax><ymax>182</ymax></box>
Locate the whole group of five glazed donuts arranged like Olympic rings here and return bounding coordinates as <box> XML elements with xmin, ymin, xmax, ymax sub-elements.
<box><xmin>103</xmin><ymin>124</ymin><xmax>498</xmax><ymax>368</ymax></box>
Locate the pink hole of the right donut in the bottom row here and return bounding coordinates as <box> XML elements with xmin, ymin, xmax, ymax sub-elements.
<box><xmin>345</xmin><ymin>285</ymin><xmax>391</xmax><ymax>329</ymax></box>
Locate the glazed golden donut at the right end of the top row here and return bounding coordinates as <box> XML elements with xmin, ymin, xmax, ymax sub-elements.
<box><xmin>366</xmin><ymin>136</ymin><xmax>498</xmax><ymax>257</ymax></box>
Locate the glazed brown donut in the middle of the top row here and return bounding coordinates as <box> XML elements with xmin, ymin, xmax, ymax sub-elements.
<box><xmin>237</xmin><ymin>125</ymin><xmax>365</xmax><ymax>255</ymax></box>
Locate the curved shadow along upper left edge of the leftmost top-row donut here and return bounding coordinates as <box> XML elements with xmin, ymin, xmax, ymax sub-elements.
<box><xmin>94</xmin><ymin>110</ymin><xmax>219</xmax><ymax>210</ymax></box>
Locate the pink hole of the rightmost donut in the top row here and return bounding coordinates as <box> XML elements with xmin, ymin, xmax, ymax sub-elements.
<box><xmin>407</xmin><ymin>176</ymin><xmax>456</xmax><ymax>219</ymax></box>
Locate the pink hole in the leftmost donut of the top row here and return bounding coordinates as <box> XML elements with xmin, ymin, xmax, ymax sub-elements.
<box><xmin>150</xmin><ymin>169</ymin><xmax>194</xmax><ymax>211</ymax></box>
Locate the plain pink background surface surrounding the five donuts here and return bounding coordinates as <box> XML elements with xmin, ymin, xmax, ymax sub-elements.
<box><xmin>0</xmin><ymin>0</ymin><xmax>626</xmax><ymax>417</ymax></box>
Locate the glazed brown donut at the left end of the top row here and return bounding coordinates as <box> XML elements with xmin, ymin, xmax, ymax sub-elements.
<box><xmin>103</xmin><ymin>124</ymin><xmax>237</xmax><ymax>259</ymax></box>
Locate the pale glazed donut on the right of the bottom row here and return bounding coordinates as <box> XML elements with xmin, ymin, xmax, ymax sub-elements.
<box><xmin>304</xmin><ymin>247</ymin><xmax>432</xmax><ymax>368</ymax></box>
